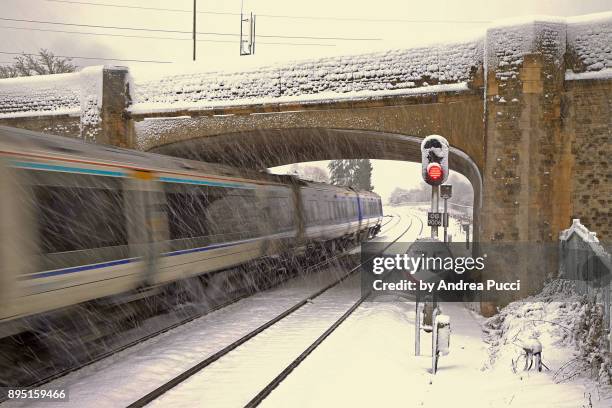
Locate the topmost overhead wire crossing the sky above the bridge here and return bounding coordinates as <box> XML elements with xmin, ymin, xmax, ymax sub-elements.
<box><xmin>44</xmin><ymin>0</ymin><xmax>491</xmax><ymax>24</ymax></box>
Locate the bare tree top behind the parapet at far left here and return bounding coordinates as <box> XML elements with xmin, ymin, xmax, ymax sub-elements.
<box><xmin>0</xmin><ymin>48</ymin><xmax>76</xmax><ymax>78</ymax></box>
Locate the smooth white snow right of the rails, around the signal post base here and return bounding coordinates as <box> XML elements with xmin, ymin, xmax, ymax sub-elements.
<box><xmin>262</xmin><ymin>207</ymin><xmax>612</xmax><ymax>408</ymax></box>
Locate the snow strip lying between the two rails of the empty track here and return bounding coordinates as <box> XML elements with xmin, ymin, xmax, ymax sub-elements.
<box><xmin>150</xmin><ymin>275</ymin><xmax>361</xmax><ymax>407</ymax></box>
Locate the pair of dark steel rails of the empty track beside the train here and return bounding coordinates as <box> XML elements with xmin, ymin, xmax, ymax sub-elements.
<box><xmin>128</xmin><ymin>212</ymin><xmax>416</xmax><ymax>408</ymax></box>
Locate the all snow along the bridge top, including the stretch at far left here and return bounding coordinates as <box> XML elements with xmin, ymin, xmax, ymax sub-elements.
<box><xmin>0</xmin><ymin>13</ymin><xmax>612</xmax><ymax>124</ymax></box>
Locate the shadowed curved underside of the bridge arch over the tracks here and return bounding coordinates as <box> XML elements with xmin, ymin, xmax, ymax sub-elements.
<box><xmin>150</xmin><ymin>128</ymin><xmax>483</xmax><ymax>241</ymax></box>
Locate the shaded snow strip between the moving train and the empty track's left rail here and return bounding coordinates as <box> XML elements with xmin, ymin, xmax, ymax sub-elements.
<box><xmin>2</xmin><ymin>209</ymin><xmax>416</xmax><ymax>407</ymax></box>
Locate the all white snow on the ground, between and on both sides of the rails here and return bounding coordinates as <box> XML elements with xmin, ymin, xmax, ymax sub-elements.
<box><xmin>5</xmin><ymin>206</ymin><xmax>612</xmax><ymax>408</ymax></box>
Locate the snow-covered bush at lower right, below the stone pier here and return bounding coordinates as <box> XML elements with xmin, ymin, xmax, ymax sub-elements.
<box><xmin>484</xmin><ymin>279</ymin><xmax>612</xmax><ymax>384</ymax></box>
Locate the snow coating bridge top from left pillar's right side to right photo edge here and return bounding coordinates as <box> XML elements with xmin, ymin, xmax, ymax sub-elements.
<box><xmin>125</xmin><ymin>13</ymin><xmax>612</xmax><ymax>114</ymax></box>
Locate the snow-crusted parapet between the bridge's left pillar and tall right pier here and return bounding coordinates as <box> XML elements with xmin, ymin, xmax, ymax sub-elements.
<box><xmin>130</xmin><ymin>40</ymin><xmax>483</xmax><ymax>116</ymax></box>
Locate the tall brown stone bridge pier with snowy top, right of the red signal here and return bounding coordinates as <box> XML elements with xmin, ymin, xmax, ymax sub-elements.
<box><xmin>482</xmin><ymin>21</ymin><xmax>572</xmax><ymax>311</ymax></box>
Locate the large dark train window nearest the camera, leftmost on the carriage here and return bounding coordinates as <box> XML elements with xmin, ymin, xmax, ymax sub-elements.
<box><xmin>31</xmin><ymin>174</ymin><xmax>127</xmax><ymax>254</ymax></box>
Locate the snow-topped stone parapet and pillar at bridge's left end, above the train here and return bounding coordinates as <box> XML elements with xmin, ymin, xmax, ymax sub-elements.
<box><xmin>0</xmin><ymin>66</ymin><xmax>134</xmax><ymax>147</ymax></box>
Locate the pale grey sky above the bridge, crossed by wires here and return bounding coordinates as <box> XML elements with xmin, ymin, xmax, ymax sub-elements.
<box><xmin>0</xmin><ymin>0</ymin><xmax>611</xmax><ymax>67</ymax></box>
